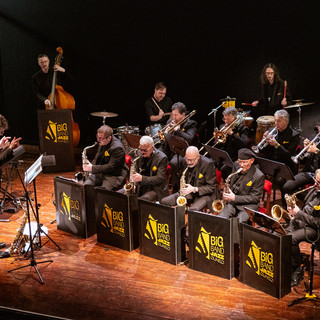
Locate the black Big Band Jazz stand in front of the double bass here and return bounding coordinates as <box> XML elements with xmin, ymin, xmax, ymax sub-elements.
<box><xmin>38</xmin><ymin>109</ymin><xmax>75</xmax><ymax>172</ymax></box>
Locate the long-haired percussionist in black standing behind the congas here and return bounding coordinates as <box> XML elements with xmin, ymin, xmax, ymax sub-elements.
<box><xmin>251</xmin><ymin>63</ymin><xmax>292</xmax><ymax>118</ymax></box>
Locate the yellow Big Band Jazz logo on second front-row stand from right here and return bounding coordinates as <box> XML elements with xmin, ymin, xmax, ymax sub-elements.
<box><xmin>196</xmin><ymin>227</ymin><xmax>224</xmax><ymax>264</ymax></box>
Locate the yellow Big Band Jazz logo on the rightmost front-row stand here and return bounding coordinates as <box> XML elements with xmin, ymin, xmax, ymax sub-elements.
<box><xmin>246</xmin><ymin>241</ymin><xmax>274</xmax><ymax>282</ymax></box>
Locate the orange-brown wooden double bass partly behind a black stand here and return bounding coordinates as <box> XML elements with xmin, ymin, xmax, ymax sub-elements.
<box><xmin>46</xmin><ymin>47</ymin><xmax>80</xmax><ymax>147</ymax></box>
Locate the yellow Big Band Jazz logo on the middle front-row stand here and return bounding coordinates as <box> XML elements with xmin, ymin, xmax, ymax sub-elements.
<box><xmin>144</xmin><ymin>214</ymin><xmax>170</xmax><ymax>251</ymax></box>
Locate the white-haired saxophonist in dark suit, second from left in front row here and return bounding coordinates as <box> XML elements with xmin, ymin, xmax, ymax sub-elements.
<box><xmin>130</xmin><ymin>136</ymin><xmax>169</xmax><ymax>201</ymax></box>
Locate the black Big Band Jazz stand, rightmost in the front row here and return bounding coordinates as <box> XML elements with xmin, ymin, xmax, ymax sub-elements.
<box><xmin>240</xmin><ymin>224</ymin><xmax>291</xmax><ymax>298</ymax></box>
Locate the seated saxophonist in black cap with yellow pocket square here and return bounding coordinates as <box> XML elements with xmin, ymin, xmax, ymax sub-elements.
<box><xmin>220</xmin><ymin>148</ymin><xmax>265</xmax><ymax>223</ymax></box>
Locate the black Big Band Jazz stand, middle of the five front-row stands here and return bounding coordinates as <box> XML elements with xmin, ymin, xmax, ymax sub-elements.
<box><xmin>138</xmin><ymin>199</ymin><xmax>185</xmax><ymax>265</ymax></box>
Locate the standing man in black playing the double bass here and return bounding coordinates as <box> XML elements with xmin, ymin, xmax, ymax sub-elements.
<box><xmin>32</xmin><ymin>53</ymin><xmax>72</xmax><ymax>109</ymax></box>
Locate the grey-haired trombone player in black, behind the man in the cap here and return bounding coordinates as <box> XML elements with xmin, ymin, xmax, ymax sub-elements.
<box><xmin>215</xmin><ymin>107</ymin><xmax>249</xmax><ymax>180</ymax></box>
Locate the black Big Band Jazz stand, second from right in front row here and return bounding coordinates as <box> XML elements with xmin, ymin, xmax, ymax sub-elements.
<box><xmin>188</xmin><ymin>211</ymin><xmax>237</xmax><ymax>279</ymax></box>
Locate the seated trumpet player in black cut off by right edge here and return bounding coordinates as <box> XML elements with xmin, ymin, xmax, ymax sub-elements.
<box><xmin>283</xmin><ymin>126</ymin><xmax>320</xmax><ymax>194</ymax></box>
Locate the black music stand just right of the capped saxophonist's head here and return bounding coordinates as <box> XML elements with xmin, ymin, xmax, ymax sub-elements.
<box><xmin>256</xmin><ymin>157</ymin><xmax>294</xmax><ymax>200</ymax></box>
